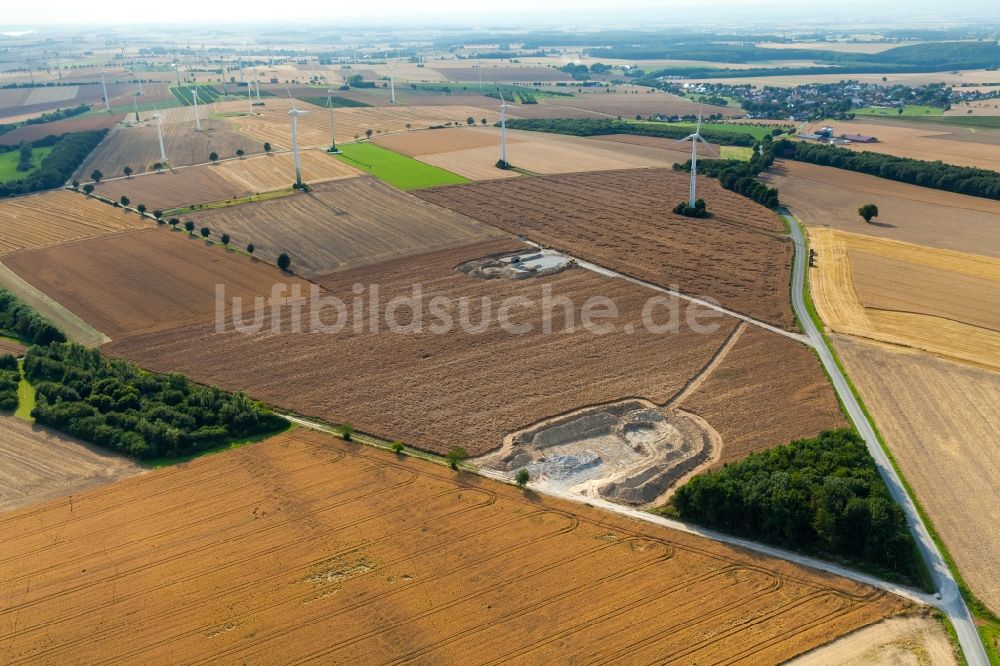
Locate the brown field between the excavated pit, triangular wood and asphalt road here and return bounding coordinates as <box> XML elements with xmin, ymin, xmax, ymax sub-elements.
<box><xmin>675</xmin><ymin>326</ymin><xmax>847</xmax><ymax>464</ymax></box>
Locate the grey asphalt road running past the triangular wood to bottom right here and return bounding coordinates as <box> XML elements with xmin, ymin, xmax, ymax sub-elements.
<box><xmin>780</xmin><ymin>209</ymin><xmax>989</xmax><ymax>666</ymax></box>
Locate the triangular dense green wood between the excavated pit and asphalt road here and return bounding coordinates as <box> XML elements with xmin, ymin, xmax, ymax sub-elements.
<box><xmin>668</xmin><ymin>430</ymin><xmax>920</xmax><ymax>582</ymax></box>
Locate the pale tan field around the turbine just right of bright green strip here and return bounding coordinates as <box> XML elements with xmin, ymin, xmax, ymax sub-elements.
<box><xmin>417</xmin><ymin>128</ymin><xmax>682</xmax><ymax>180</ymax></box>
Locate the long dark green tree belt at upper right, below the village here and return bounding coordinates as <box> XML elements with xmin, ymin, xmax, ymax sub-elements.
<box><xmin>774</xmin><ymin>139</ymin><xmax>1000</xmax><ymax>199</ymax></box>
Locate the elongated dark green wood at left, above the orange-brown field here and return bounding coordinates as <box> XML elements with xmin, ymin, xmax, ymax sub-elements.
<box><xmin>24</xmin><ymin>342</ymin><xmax>287</xmax><ymax>458</ymax></box>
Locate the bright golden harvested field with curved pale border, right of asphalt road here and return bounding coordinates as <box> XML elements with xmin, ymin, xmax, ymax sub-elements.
<box><xmin>809</xmin><ymin>227</ymin><xmax>1000</xmax><ymax>368</ymax></box>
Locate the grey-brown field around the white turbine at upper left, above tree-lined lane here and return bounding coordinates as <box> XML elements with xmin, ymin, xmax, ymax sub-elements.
<box><xmin>75</xmin><ymin>116</ymin><xmax>264</xmax><ymax>182</ymax></box>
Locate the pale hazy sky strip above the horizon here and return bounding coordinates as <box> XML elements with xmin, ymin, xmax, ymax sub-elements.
<box><xmin>0</xmin><ymin>0</ymin><xmax>1000</xmax><ymax>30</ymax></box>
